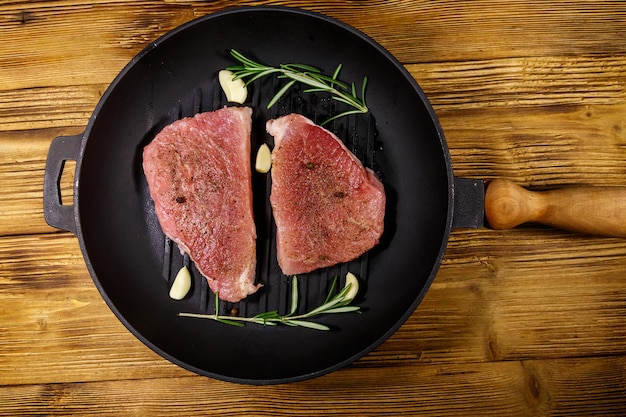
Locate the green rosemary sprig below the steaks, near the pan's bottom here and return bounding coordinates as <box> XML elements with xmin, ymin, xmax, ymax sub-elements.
<box><xmin>178</xmin><ymin>276</ymin><xmax>360</xmax><ymax>330</ymax></box>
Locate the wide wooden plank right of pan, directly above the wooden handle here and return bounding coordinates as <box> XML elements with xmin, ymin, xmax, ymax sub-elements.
<box><xmin>407</xmin><ymin>57</ymin><xmax>626</xmax><ymax>186</ymax></box>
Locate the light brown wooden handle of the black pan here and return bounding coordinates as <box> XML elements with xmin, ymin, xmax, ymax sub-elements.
<box><xmin>485</xmin><ymin>179</ymin><xmax>626</xmax><ymax>237</ymax></box>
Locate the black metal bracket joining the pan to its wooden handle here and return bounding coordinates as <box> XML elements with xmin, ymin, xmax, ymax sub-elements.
<box><xmin>452</xmin><ymin>177</ymin><xmax>485</xmax><ymax>229</ymax></box>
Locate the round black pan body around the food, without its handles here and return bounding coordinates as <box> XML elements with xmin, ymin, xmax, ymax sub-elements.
<box><xmin>67</xmin><ymin>7</ymin><xmax>453</xmax><ymax>384</ymax></box>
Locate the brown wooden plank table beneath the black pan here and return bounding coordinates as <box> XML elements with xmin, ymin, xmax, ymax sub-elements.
<box><xmin>0</xmin><ymin>0</ymin><xmax>626</xmax><ymax>416</ymax></box>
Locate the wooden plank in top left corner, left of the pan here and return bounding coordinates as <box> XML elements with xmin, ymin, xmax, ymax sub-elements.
<box><xmin>0</xmin><ymin>1</ymin><xmax>194</xmax><ymax>89</ymax></box>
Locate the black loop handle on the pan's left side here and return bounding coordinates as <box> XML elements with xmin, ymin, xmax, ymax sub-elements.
<box><xmin>43</xmin><ymin>134</ymin><xmax>83</xmax><ymax>234</ymax></box>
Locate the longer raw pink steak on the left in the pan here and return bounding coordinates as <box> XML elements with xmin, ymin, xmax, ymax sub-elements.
<box><xmin>143</xmin><ymin>107</ymin><xmax>260</xmax><ymax>302</ymax></box>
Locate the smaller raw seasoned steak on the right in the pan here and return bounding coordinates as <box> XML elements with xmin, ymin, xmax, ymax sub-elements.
<box><xmin>267</xmin><ymin>114</ymin><xmax>385</xmax><ymax>275</ymax></box>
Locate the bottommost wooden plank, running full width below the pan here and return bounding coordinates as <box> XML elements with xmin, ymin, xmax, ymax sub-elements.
<box><xmin>0</xmin><ymin>357</ymin><xmax>626</xmax><ymax>417</ymax></box>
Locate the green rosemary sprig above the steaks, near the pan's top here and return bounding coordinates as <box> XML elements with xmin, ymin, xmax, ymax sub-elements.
<box><xmin>226</xmin><ymin>49</ymin><xmax>369</xmax><ymax>125</ymax></box>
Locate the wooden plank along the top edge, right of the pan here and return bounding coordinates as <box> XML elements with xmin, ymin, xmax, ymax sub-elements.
<box><xmin>326</xmin><ymin>0</ymin><xmax>626</xmax><ymax>63</ymax></box>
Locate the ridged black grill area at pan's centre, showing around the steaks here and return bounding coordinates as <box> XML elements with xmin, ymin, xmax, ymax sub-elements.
<box><xmin>157</xmin><ymin>69</ymin><xmax>382</xmax><ymax>318</ymax></box>
